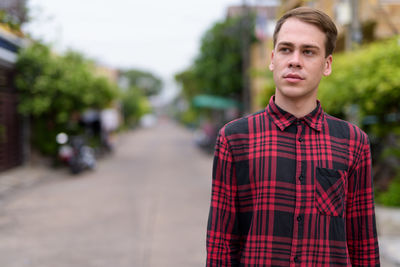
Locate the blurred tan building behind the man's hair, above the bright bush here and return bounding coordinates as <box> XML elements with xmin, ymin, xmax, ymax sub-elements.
<box><xmin>279</xmin><ymin>0</ymin><xmax>400</xmax><ymax>52</ymax></box>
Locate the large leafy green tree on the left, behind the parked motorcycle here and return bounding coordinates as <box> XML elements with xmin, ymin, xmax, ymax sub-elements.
<box><xmin>15</xmin><ymin>43</ymin><xmax>118</xmax><ymax>154</ymax></box>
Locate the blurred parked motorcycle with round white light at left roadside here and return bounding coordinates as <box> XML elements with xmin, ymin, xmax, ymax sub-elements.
<box><xmin>56</xmin><ymin>133</ymin><xmax>96</xmax><ymax>174</ymax></box>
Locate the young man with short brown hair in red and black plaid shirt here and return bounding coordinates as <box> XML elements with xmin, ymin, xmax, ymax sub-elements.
<box><xmin>207</xmin><ymin>7</ymin><xmax>379</xmax><ymax>267</ymax></box>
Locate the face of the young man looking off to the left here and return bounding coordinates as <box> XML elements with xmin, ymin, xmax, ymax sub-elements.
<box><xmin>269</xmin><ymin>18</ymin><xmax>332</xmax><ymax>100</ymax></box>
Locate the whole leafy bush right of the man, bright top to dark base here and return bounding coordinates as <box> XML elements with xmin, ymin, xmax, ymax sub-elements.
<box><xmin>319</xmin><ymin>39</ymin><xmax>400</xmax><ymax>206</ymax></box>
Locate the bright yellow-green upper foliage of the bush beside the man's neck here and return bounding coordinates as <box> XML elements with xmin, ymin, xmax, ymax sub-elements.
<box><xmin>319</xmin><ymin>39</ymin><xmax>400</xmax><ymax>122</ymax></box>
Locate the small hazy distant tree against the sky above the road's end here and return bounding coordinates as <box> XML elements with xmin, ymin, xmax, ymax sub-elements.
<box><xmin>122</xmin><ymin>69</ymin><xmax>163</xmax><ymax>96</ymax></box>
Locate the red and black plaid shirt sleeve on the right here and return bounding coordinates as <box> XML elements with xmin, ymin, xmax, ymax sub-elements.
<box><xmin>346</xmin><ymin>134</ymin><xmax>380</xmax><ymax>266</ymax></box>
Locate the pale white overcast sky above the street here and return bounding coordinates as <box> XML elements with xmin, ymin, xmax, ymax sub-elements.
<box><xmin>24</xmin><ymin>0</ymin><xmax>276</xmax><ymax>79</ymax></box>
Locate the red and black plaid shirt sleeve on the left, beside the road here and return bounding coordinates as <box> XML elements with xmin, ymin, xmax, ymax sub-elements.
<box><xmin>206</xmin><ymin>128</ymin><xmax>241</xmax><ymax>267</ymax></box>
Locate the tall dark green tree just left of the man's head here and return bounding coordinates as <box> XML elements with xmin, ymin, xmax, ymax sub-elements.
<box><xmin>193</xmin><ymin>14</ymin><xmax>255</xmax><ymax>100</ymax></box>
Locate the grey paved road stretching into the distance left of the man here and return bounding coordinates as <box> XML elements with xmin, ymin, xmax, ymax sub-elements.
<box><xmin>0</xmin><ymin>123</ymin><xmax>212</xmax><ymax>267</ymax></box>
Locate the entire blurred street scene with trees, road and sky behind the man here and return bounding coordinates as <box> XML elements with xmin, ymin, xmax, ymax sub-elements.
<box><xmin>0</xmin><ymin>0</ymin><xmax>400</xmax><ymax>266</ymax></box>
